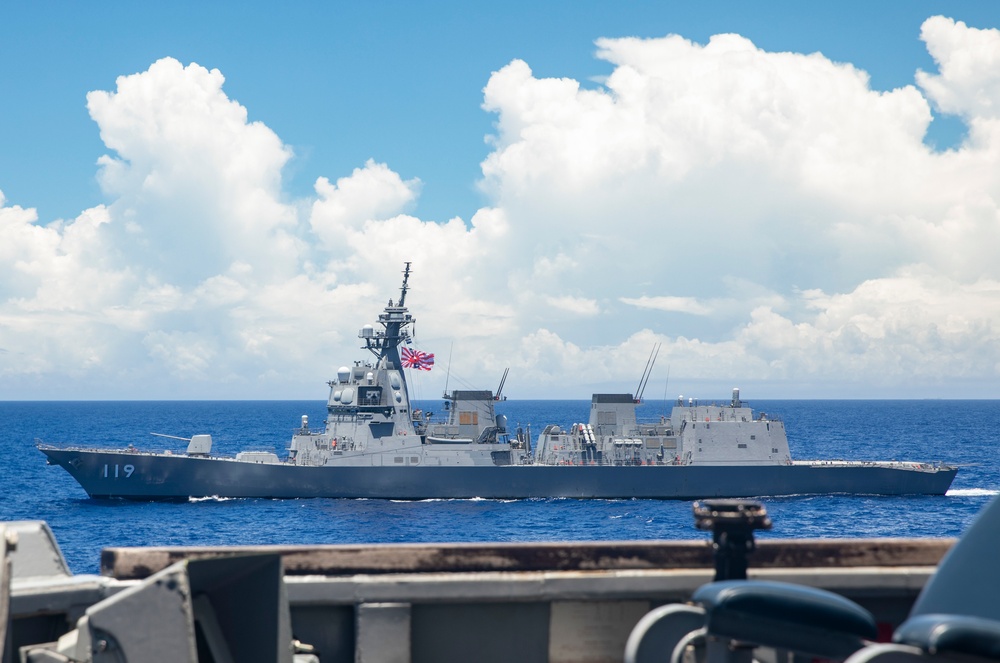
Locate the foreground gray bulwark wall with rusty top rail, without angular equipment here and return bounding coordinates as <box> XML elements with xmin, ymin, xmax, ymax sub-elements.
<box><xmin>11</xmin><ymin>524</ymin><xmax>954</xmax><ymax>663</ymax></box>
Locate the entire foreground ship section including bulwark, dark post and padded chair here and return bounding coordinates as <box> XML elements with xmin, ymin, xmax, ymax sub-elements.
<box><xmin>17</xmin><ymin>498</ymin><xmax>1000</xmax><ymax>663</ymax></box>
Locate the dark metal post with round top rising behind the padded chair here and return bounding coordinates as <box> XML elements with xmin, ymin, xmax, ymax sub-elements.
<box><xmin>693</xmin><ymin>500</ymin><xmax>771</xmax><ymax>581</ymax></box>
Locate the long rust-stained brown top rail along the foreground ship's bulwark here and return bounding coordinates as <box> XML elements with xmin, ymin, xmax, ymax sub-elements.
<box><xmin>101</xmin><ymin>539</ymin><xmax>955</xmax><ymax>580</ymax></box>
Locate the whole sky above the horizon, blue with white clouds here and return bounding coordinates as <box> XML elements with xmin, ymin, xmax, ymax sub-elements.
<box><xmin>0</xmin><ymin>1</ymin><xmax>1000</xmax><ymax>398</ymax></box>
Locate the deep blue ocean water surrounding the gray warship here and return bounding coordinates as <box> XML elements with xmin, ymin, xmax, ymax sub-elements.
<box><xmin>0</xmin><ymin>400</ymin><xmax>1000</xmax><ymax>573</ymax></box>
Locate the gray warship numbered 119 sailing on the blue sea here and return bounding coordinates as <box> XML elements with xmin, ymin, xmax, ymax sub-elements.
<box><xmin>38</xmin><ymin>263</ymin><xmax>958</xmax><ymax>500</ymax></box>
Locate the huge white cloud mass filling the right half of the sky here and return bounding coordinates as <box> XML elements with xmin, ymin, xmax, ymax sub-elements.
<box><xmin>472</xmin><ymin>17</ymin><xmax>1000</xmax><ymax>396</ymax></box>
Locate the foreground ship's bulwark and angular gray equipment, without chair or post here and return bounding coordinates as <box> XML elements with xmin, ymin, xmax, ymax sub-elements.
<box><xmin>0</xmin><ymin>521</ymin><xmax>954</xmax><ymax>663</ymax></box>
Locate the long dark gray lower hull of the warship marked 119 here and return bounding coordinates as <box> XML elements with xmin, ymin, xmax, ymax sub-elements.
<box><xmin>40</xmin><ymin>446</ymin><xmax>957</xmax><ymax>500</ymax></box>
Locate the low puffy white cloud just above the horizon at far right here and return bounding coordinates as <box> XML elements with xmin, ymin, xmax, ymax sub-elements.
<box><xmin>738</xmin><ymin>272</ymin><xmax>1000</xmax><ymax>385</ymax></box>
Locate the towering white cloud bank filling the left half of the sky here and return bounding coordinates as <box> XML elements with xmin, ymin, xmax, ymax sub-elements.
<box><xmin>0</xmin><ymin>58</ymin><xmax>511</xmax><ymax>397</ymax></box>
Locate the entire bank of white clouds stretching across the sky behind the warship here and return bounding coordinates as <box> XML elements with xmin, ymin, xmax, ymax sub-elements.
<box><xmin>0</xmin><ymin>17</ymin><xmax>1000</xmax><ymax>398</ymax></box>
